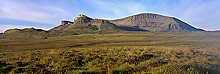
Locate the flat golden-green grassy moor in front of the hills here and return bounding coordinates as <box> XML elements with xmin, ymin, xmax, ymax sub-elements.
<box><xmin>0</xmin><ymin>32</ymin><xmax>220</xmax><ymax>74</ymax></box>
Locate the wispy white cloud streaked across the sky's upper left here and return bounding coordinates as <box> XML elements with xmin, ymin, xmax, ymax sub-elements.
<box><xmin>0</xmin><ymin>0</ymin><xmax>68</xmax><ymax>24</ymax></box>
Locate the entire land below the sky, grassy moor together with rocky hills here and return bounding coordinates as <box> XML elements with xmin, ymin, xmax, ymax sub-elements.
<box><xmin>0</xmin><ymin>13</ymin><xmax>220</xmax><ymax>74</ymax></box>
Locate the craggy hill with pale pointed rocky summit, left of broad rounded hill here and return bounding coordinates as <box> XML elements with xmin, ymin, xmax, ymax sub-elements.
<box><xmin>50</xmin><ymin>14</ymin><xmax>120</xmax><ymax>33</ymax></box>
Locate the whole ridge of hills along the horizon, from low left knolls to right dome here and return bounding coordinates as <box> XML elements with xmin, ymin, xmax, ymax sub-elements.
<box><xmin>2</xmin><ymin>13</ymin><xmax>205</xmax><ymax>35</ymax></box>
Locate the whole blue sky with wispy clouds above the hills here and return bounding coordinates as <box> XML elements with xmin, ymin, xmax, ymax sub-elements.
<box><xmin>0</xmin><ymin>0</ymin><xmax>220</xmax><ymax>32</ymax></box>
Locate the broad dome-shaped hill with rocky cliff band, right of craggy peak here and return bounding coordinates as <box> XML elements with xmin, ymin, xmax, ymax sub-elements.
<box><xmin>110</xmin><ymin>13</ymin><xmax>203</xmax><ymax>32</ymax></box>
